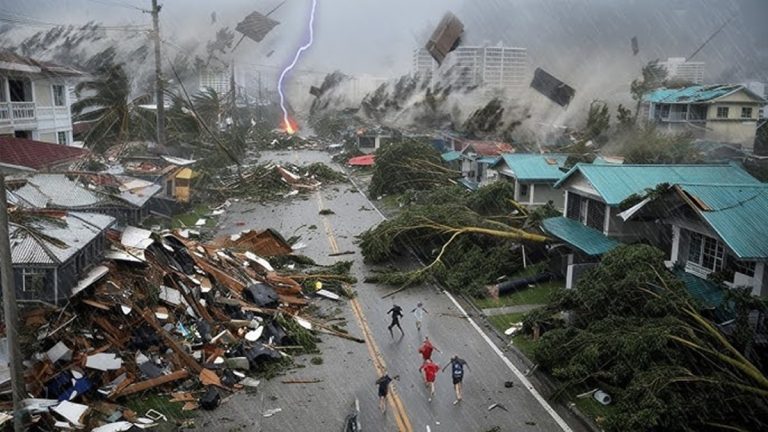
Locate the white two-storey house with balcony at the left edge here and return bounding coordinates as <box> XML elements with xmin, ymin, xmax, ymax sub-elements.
<box><xmin>0</xmin><ymin>51</ymin><xmax>82</xmax><ymax>145</ymax></box>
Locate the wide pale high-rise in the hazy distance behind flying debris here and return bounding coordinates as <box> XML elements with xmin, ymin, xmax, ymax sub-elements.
<box><xmin>413</xmin><ymin>46</ymin><xmax>528</xmax><ymax>89</ymax></box>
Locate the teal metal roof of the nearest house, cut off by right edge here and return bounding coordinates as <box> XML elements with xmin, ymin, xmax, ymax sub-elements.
<box><xmin>677</xmin><ymin>184</ymin><xmax>768</xmax><ymax>260</ymax></box>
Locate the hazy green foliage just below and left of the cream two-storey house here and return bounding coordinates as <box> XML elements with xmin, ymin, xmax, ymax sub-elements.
<box><xmin>619</xmin><ymin>123</ymin><xmax>698</xmax><ymax>164</ymax></box>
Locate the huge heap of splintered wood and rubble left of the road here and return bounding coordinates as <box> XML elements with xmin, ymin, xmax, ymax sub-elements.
<box><xmin>2</xmin><ymin>227</ymin><xmax>360</xmax><ymax>430</ymax></box>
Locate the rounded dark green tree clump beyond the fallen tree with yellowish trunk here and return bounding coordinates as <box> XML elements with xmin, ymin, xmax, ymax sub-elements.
<box><xmin>368</xmin><ymin>140</ymin><xmax>458</xmax><ymax>197</ymax></box>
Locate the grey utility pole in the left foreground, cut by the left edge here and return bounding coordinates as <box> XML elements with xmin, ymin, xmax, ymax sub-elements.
<box><xmin>0</xmin><ymin>173</ymin><xmax>27</xmax><ymax>432</ymax></box>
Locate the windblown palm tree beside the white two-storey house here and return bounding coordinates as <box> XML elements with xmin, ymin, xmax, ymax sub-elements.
<box><xmin>72</xmin><ymin>65</ymin><xmax>154</xmax><ymax>153</ymax></box>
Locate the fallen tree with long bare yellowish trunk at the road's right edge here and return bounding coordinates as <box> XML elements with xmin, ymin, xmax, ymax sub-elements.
<box><xmin>360</xmin><ymin>181</ymin><xmax>546</xmax><ymax>295</ymax></box>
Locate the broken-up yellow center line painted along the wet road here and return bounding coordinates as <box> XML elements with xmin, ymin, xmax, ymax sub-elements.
<box><xmin>316</xmin><ymin>192</ymin><xmax>413</xmax><ymax>432</ymax></box>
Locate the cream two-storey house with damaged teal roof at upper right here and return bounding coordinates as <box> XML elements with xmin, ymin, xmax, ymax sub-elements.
<box><xmin>644</xmin><ymin>84</ymin><xmax>766</xmax><ymax>152</ymax></box>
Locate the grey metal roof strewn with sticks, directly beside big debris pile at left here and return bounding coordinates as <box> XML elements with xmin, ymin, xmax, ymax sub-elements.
<box><xmin>8</xmin><ymin>212</ymin><xmax>115</xmax><ymax>265</ymax></box>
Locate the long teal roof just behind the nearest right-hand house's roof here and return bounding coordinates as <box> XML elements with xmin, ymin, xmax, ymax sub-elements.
<box><xmin>555</xmin><ymin>163</ymin><xmax>762</xmax><ymax>206</ymax></box>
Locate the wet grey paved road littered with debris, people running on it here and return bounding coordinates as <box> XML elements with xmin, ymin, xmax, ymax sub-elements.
<box><xmin>197</xmin><ymin>151</ymin><xmax>583</xmax><ymax>432</ymax></box>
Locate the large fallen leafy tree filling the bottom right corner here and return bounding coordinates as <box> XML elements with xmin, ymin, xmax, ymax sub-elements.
<box><xmin>524</xmin><ymin>245</ymin><xmax>768</xmax><ymax>431</ymax></box>
